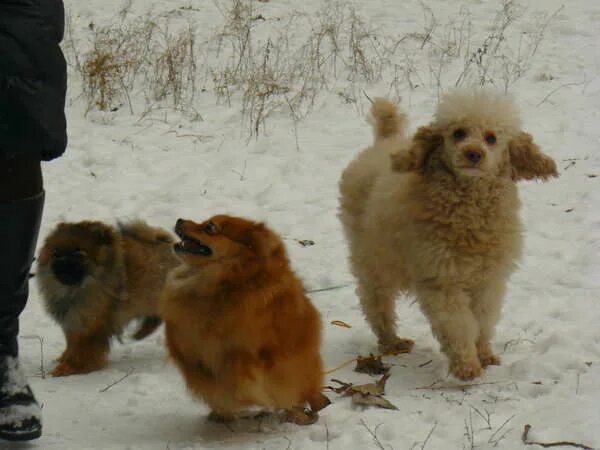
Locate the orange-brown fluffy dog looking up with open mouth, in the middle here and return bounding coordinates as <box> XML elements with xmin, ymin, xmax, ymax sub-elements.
<box><xmin>160</xmin><ymin>215</ymin><xmax>329</xmax><ymax>424</ymax></box>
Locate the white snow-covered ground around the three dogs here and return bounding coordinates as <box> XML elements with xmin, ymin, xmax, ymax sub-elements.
<box><xmin>12</xmin><ymin>0</ymin><xmax>600</xmax><ymax>450</ymax></box>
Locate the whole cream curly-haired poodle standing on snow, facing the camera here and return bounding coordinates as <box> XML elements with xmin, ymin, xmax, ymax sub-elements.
<box><xmin>340</xmin><ymin>90</ymin><xmax>557</xmax><ymax>379</ymax></box>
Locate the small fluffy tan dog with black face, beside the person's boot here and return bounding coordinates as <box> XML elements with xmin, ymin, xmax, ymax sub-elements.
<box><xmin>36</xmin><ymin>221</ymin><xmax>179</xmax><ymax>376</ymax></box>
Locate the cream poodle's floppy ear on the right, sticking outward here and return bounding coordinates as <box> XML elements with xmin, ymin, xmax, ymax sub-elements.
<box><xmin>508</xmin><ymin>132</ymin><xmax>558</xmax><ymax>181</ymax></box>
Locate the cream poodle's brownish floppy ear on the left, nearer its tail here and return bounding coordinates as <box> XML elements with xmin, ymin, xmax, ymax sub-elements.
<box><xmin>392</xmin><ymin>126</ymin><xmax>444</xmax><ymax>172</ymax></box>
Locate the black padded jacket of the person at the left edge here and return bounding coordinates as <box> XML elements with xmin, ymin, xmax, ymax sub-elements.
<box><xmin>0</xmin><ymin>0</ymin><xmax>67</xmax><ymax>164</ymax></box>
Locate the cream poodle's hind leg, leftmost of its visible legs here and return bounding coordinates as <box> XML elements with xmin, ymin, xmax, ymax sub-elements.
<box><xmin>356</xmin><ymin>280</ymin><xmax>414</xmax><ymax>353</ymax></box>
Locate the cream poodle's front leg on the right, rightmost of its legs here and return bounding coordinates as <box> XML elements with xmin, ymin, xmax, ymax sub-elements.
<box><xmin>471</xmin><ymin>277</ymin><xmax>506</xmax><ymax>367</ymax></box>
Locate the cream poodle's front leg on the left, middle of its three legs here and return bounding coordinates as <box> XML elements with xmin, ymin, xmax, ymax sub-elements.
<box><xmin>417</xmin><ymin>285</ymin><xmax>481</xmax><ymax>380</ymax></box>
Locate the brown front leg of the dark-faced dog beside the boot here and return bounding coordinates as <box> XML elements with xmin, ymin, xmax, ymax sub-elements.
<box><xmin>52</xmin><ymin>332</ymin><xmax>110</xmax><ymax>377</ymax></box>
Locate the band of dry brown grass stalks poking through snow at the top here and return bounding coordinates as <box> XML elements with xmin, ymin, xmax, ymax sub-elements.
<box><xmin>65</xmin><ymin>0</ymin><xmax>558</xmax><ymax>137</ymax></box>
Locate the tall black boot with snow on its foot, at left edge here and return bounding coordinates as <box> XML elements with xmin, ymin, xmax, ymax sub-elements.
<box><xmin>0</xmin><ymin>192</ymin><xmax>44</xmax><ymax>441</ymax></box>
